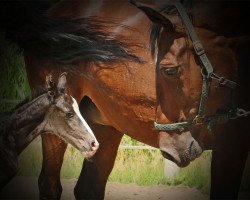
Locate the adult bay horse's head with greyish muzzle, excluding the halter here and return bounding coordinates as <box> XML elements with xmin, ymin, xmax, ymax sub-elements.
<box><xmin>131</xmin><ymin>1</ymin><xmax>237</xmax><ymax>166</ymax></box>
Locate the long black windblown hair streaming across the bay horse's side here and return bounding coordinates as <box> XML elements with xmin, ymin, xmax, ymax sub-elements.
<box><xmin>16</xmin><ymin>17</ymin><xmax>144</xmax><ymax>64</ymax></box>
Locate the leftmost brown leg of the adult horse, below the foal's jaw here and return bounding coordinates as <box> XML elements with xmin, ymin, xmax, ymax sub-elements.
<box><xmin>38</xmin><ymin>134</ymin><xmax>67</xmax><ymax>199</ymax></box>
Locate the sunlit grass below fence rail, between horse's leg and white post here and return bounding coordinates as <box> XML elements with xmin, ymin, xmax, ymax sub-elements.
<box><xmin>109</xmin><ymin>149</ymin><xmax>165</xmax><ymax>185</ymax></box>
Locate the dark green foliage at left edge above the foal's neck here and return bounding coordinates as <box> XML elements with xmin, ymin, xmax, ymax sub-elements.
<box><xmin>0</xmin><ymin>33</ymin><xmax>30</xmax><ymax>111</ymax></box>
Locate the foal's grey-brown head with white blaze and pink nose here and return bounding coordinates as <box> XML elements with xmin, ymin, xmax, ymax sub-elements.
<box><xmin>43</xmin><ymin>73</ymin><xmax>99</xmax><ymax>157</ymax></box>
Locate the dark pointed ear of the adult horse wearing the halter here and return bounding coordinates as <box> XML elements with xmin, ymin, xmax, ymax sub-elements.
<box><xmin>129</xmin><ymin>0</ymin><xmax>174</xmax><ymax>32</ymax></box>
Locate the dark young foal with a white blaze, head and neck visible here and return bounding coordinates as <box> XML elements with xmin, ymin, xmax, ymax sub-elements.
<box><xmin>0</xmin><ymin>73</ymin><xmax>99</xmax><ymax>189</ymax></box>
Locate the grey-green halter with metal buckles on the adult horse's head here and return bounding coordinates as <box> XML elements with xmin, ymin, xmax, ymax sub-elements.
<box><xmin>154</xmin><ymin>2</ymin><xmax>250</xmax><ymax>132</ymax></box>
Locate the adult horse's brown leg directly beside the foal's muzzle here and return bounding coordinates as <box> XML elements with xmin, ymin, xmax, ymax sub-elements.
<box><xmin>74</xmin><ymin>125</ymin><xmax>123</xmax><ymax>200</ymax></box>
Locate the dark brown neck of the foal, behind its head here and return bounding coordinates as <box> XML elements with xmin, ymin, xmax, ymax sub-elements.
<box><xmin>4</xmin><ymin>94</ymin><xmax>51</xmax><ymax>155</ymax></box>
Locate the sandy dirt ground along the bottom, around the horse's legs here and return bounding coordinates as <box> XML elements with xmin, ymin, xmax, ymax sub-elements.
<box><xmin>0</xmin><ymin>177</ymin><xmax>209</xmax><ymax>200</ymax></box>
